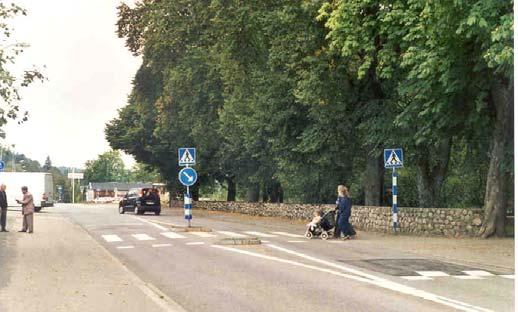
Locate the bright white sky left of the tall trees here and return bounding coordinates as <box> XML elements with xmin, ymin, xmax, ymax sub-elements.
<box><xmin>4</xmin><ymin>0</ymin><xmax>141</xmax><ymax>167</ymax></box>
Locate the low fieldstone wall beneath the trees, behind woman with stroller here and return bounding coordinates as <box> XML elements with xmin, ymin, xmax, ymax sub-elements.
<box><xmin>194</xmin><ymin>201</ymin><xmax>483</xmax><ymax>237</ymax></box>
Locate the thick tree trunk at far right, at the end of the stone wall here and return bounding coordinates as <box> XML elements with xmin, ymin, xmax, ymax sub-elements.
<box><xmin>479</xmin><ymin>82</ymin><xmax>513</xmax><ymax>238</ymax></box>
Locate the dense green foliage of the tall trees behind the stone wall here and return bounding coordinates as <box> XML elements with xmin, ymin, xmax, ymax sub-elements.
<box><xmin>106</xmin><ymin>0</ymin><xmax>513</xmax><ymax>207</ymax></box>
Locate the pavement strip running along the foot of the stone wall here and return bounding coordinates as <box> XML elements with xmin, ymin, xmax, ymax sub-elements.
<box><xmin>183</xmin><ymin>208</ymin><xmax>515</xmax><ymax>270</ymax></box>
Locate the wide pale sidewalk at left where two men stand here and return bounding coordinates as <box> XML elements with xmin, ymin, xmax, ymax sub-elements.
<box><xmin>0</xmin><ymin>211</ymin><xmax>181</xmax><ymax>312</ymax></box>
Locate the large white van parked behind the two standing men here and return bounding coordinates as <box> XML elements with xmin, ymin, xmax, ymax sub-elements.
<box><xmin>0</xmin><ymin>172</ymin><xmax>54</xmax><ymax>211</ymax></box>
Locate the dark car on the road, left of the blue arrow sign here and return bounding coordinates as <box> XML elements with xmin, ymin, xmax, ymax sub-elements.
<box><xmin>119</xmin><ymin>188</ymin><xmax>161</xmax><ymax>216</ymax></box>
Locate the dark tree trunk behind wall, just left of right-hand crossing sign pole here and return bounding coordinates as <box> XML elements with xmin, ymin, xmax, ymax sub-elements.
<box><xmin>364</xmin><ymin>155</ymin><xmax>383</xmax><ymax>206</ymax></box>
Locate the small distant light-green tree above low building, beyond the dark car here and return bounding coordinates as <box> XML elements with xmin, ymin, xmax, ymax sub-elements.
<box><xmin>84</xmin><ymin>151</ymin><xmax>128</xmax><ymax>183</ymax></box>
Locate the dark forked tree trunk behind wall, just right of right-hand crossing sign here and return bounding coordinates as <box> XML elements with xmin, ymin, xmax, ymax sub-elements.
<box><xmin>417</xmin><ymin>138</ymin><xmax>452</xmax><ymax>208</ymax></box>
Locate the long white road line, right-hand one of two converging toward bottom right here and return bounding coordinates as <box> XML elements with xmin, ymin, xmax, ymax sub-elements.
<box><xmin>266</xmin><ymin>244</ymin><xmax>492</xmax><ymax>312</ymax></box>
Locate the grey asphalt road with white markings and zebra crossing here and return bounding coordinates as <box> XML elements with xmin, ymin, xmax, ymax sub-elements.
<box><xmin>58</xmin><ymin>205</ymin><xmax>514</xmax><ymax>312</ymax></box>
